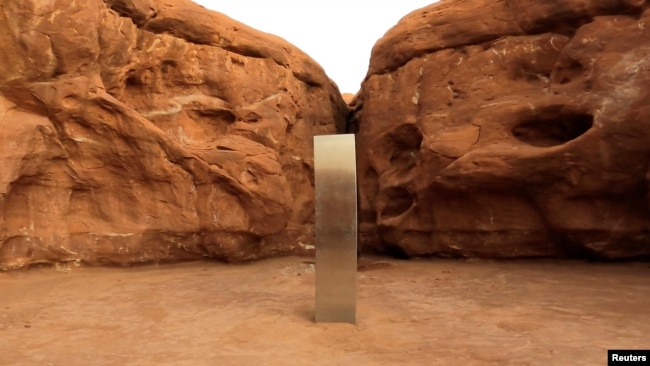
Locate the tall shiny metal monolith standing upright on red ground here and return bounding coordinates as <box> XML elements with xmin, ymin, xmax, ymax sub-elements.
<box><xmin>314</xmin><ymin>135</ymin><xmax>357</xmax><ymax>323</ymax></box>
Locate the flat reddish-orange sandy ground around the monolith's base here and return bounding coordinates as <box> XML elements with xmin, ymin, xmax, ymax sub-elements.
<box><xmin>0</xmin><ymin>257</ymin><xmax>650</xmax><ymax>366</ymax></box>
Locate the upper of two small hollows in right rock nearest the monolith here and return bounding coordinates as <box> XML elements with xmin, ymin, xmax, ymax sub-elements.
<box><xmin>387</xmin><ymin>124</ymin><xmax>423</xmax><ymax>170</ymax></box>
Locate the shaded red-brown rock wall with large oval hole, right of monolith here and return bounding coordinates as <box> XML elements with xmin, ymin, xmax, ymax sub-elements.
<box><xmin>351</xmin><ymin>0</ymin><xmax>650</xmax><ymax>258</ymax></box>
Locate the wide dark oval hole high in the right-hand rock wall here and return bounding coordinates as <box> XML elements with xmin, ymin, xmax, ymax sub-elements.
<box><xmin>512</xmin><ymin>111</ymin><xmax>594</xmax><ymax>147</ymax></box>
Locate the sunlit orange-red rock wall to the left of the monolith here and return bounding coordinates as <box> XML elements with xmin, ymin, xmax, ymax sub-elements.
<box><xmin>0</xmin><ymin>0</ymin><xmax>347</xmax><ymax>268</ymax></box>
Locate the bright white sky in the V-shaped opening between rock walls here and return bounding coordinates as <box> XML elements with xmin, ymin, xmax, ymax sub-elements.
<box><xmin>194</xmin><ymin>0</ymin><xmax>436</xmax><ymax>93</ymax></box>
